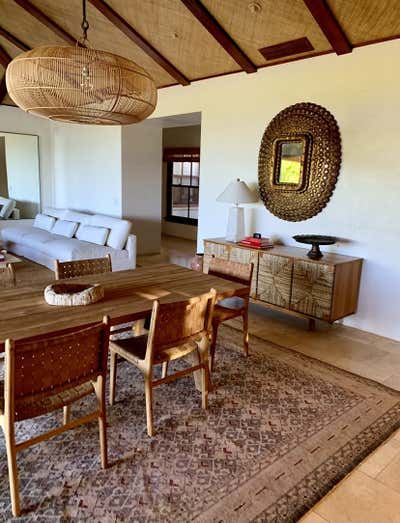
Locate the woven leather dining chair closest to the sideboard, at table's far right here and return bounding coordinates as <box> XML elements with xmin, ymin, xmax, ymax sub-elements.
<box><xmin>208</xmin><ymin>257</ymin><xmax>254</xmax><ymax>371</ymax></box>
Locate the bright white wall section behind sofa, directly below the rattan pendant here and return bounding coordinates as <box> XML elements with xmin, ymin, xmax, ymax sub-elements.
<box><xmin>52</xmin><ymin>123</ymin><xmax>122</xmax><ymax>217</ymax></box>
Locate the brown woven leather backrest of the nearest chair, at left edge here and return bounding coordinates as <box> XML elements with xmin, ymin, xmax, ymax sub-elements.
<box><xmin>4</xmin><ymin>317</ymin><xmax>110</xmax><ymax>412</ymax></box>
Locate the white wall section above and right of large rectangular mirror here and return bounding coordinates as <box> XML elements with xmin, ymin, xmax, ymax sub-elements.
<box><xmin>0</xmin><ymin>105</ymin><xmax>54</xmax><ymax>206</ymax></box>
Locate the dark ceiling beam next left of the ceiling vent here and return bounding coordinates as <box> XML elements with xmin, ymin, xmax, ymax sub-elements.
<box><xmin>181</xmin><ymin>0</ymin><xmax>257</xmax><ymax>73</ymax></box>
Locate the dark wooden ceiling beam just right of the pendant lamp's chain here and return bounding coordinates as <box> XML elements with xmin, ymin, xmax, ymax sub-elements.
<box><xmin>89</xmin><ymin>0</ymin><xmax>190</xmax><ymax>85</ymax></box>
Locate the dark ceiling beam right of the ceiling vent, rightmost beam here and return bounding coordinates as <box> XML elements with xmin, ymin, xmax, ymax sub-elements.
<box><xmin>303</xmin><ymin>0</ymin><xmax>353</xmax><ymax>54</ymax></box>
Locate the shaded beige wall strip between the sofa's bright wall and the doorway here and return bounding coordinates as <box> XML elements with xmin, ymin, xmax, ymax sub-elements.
<box><xmin>122</xmin><ymin>121</ymin><xmax>162</xmax><ymax>254</ymax></box>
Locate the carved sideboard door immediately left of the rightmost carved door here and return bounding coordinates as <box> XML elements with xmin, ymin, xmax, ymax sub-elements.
<box><xmin>257</xmin><ymin>252</ymin><xmax>293</xmax><ymax>309</ymax></box>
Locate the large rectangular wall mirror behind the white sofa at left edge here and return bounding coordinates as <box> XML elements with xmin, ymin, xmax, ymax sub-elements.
<box><xmin>0</xmin><ymin>131</ymin><xmax>40</xmax><ymax>219</ymax></box>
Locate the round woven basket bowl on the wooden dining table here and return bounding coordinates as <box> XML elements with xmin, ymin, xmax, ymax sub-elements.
<box><xmin>44</xmin><ymin>283</ymin><xmax>104</xmax><ymax>307</ymax></box>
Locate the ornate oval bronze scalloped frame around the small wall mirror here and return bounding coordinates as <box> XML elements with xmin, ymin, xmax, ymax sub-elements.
<box><xmin>258</xmin><ymin>103</ymin><xmax>342</xmax><ymax>222</ymax></box>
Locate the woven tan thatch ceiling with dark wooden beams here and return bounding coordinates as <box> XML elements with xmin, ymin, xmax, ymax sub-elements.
<box><xmin>0</xmin><ymin>0</ymin><xmax>400</xmax><ymax>104</ymax></box>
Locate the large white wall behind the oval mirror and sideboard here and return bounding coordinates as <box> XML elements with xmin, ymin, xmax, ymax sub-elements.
<box><xmin>154</xmin><ymin>41</ymin><xmax>400</xmax><ymax>339</ymax></box>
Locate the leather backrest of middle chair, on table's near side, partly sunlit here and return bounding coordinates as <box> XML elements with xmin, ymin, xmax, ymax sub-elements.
<box><xmin>148</xmin><ymin>289</ymin><xmax>216</xmax><ymax>353</ymax></box>
